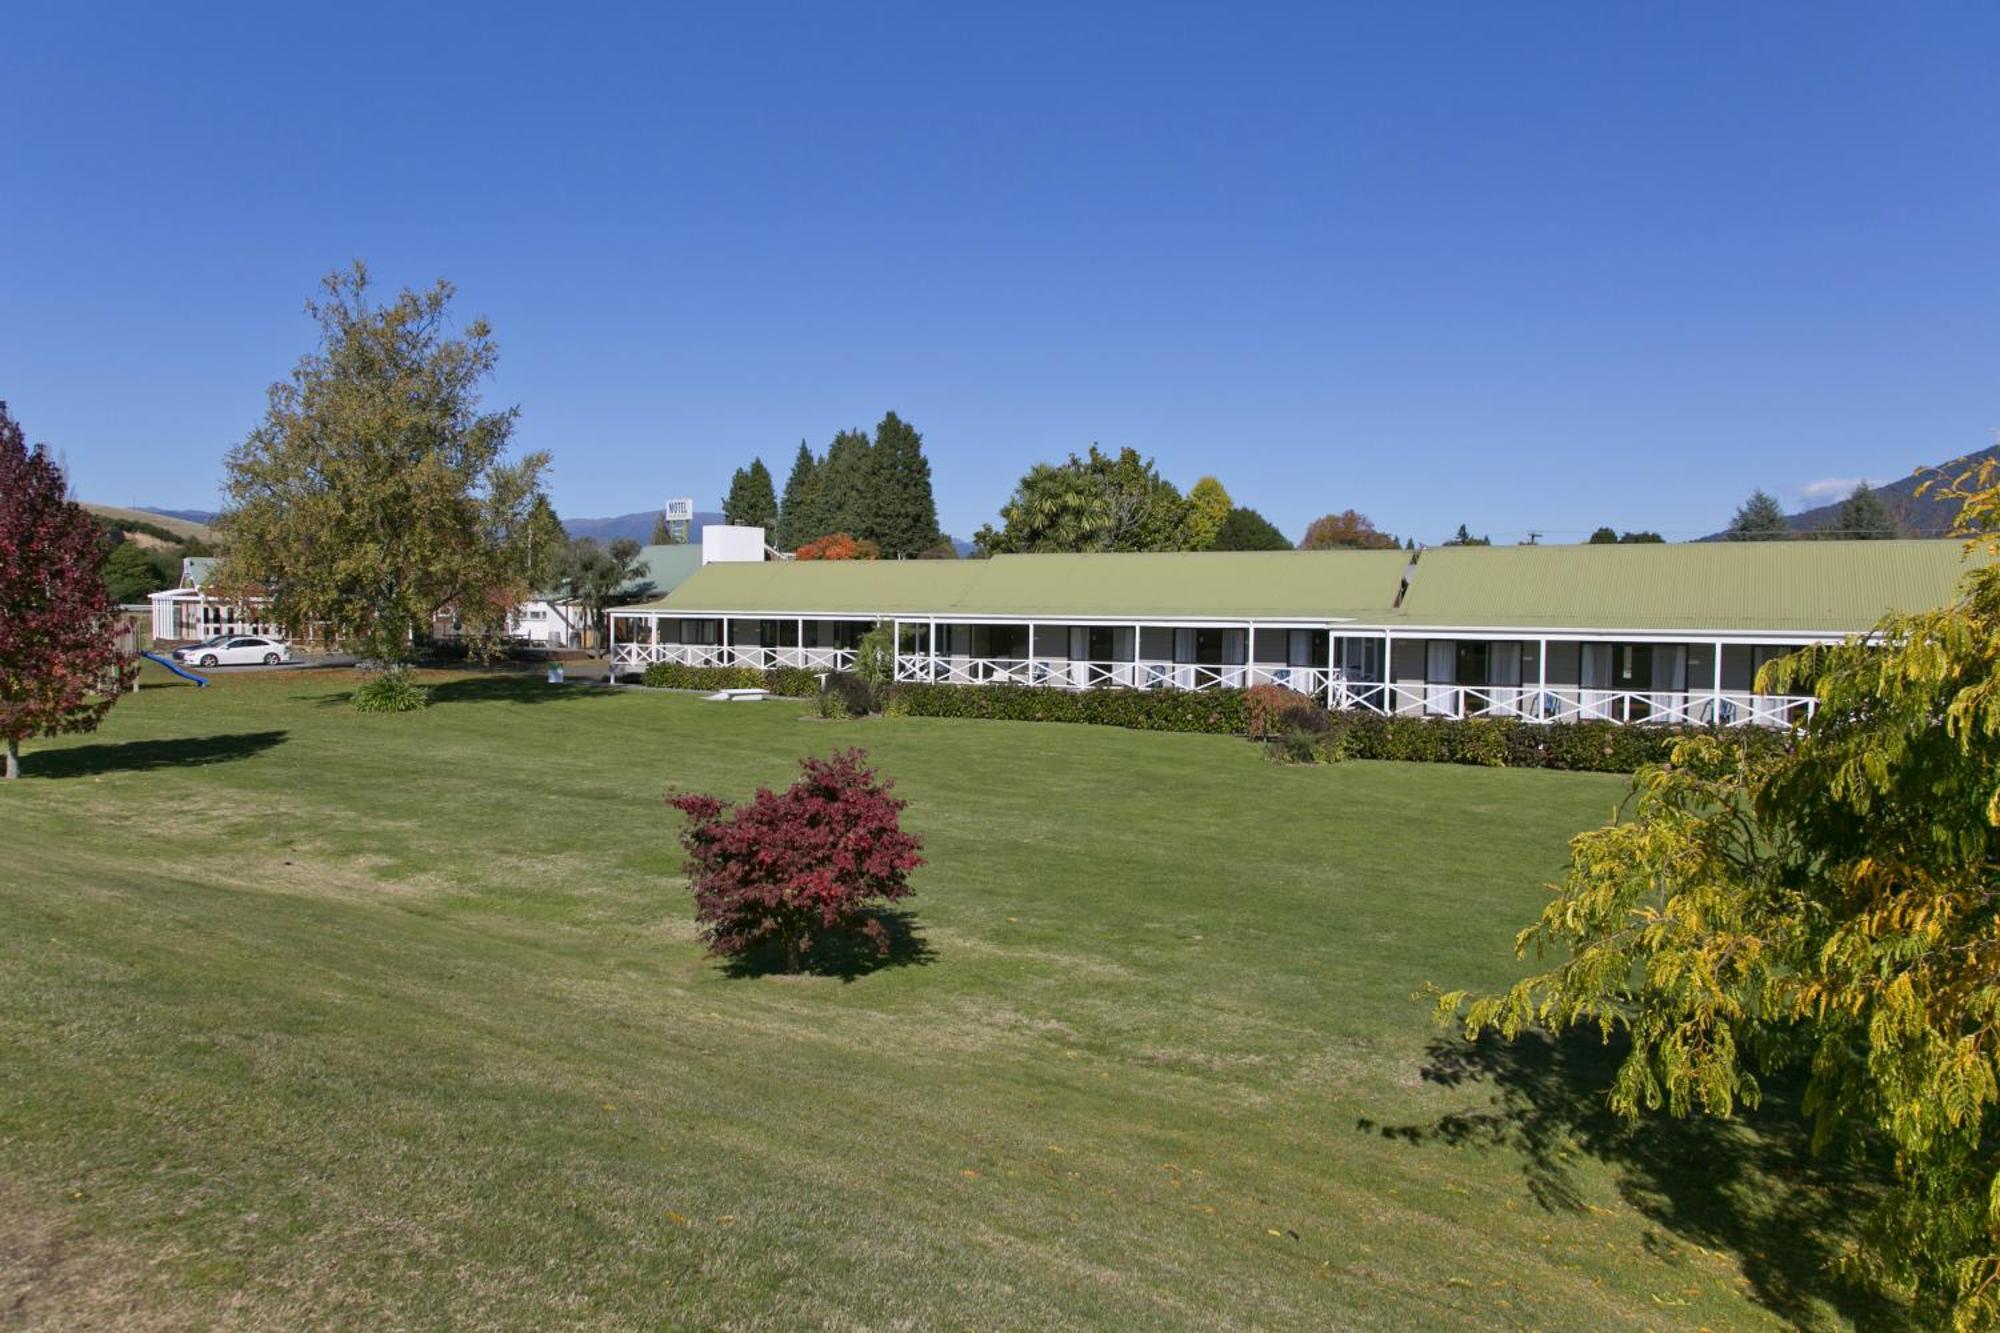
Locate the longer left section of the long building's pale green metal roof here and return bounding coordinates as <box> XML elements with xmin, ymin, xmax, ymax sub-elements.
<box><xmin>626</xmin><ymin>550</ymin><xmax>1408</xmax><ymax>620</ymax></box>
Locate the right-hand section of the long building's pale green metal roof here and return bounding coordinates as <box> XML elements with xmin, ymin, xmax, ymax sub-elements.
<box><xmin>1390</xmin><ymin>540</ymin><xmax>1964</xmax><ymax>632</ymax></box>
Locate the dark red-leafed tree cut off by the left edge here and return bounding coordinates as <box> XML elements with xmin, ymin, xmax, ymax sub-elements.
<box><xmin>0</xmin><ymin>402</ymin><xmax>132</xmax><ymax>779</ymax></box>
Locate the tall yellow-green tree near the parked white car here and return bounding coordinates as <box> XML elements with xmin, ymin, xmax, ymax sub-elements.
<box><xmin>216</xmin><ymin>264</ymin><xmax>564</xmax><ymax>664</ymax></box>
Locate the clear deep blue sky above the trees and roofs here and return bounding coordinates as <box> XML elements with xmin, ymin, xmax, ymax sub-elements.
<box><xmin>0</xmin><ymin>2</ymin><xmax>2000</xmax><ymax>540</ymax></box>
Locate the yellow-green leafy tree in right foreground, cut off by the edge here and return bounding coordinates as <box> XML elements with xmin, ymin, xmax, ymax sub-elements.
<box><xmin>1440</xmin><ymin>460</ymin><xmax>2000</xmax><ymax>1329</ymax></box>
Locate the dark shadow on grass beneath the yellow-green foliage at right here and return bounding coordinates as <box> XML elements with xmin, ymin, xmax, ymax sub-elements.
<box><xmin>1356</xmin><ymin>1033</ymin><xmax>1914</xmax><ymax>1329</ymax></box>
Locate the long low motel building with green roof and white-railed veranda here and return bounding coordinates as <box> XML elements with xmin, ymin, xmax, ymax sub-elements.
<box><xmin>612</xmin><ymin>540</ymin><xmax>1964</xmax><ymax>727</ymax></box>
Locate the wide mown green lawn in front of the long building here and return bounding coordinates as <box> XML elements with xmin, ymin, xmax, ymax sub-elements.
<box><xmin>0</xmin><ymin>675</ymin><xmax>1880</xmax><ymax>1329</ymax></box>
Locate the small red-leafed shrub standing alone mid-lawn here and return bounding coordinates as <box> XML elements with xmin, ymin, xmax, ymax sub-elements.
<box><xmin>668</xmin><ymin>751</ymin><xmax>924</xmax><ymax>973</ymax></box>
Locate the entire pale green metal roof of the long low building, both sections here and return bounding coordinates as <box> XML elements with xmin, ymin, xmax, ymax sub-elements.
<box><xmin>628</xmin><ymin>540</ymin><xmax>1964</xmax><ymax>632</ymax></box>
